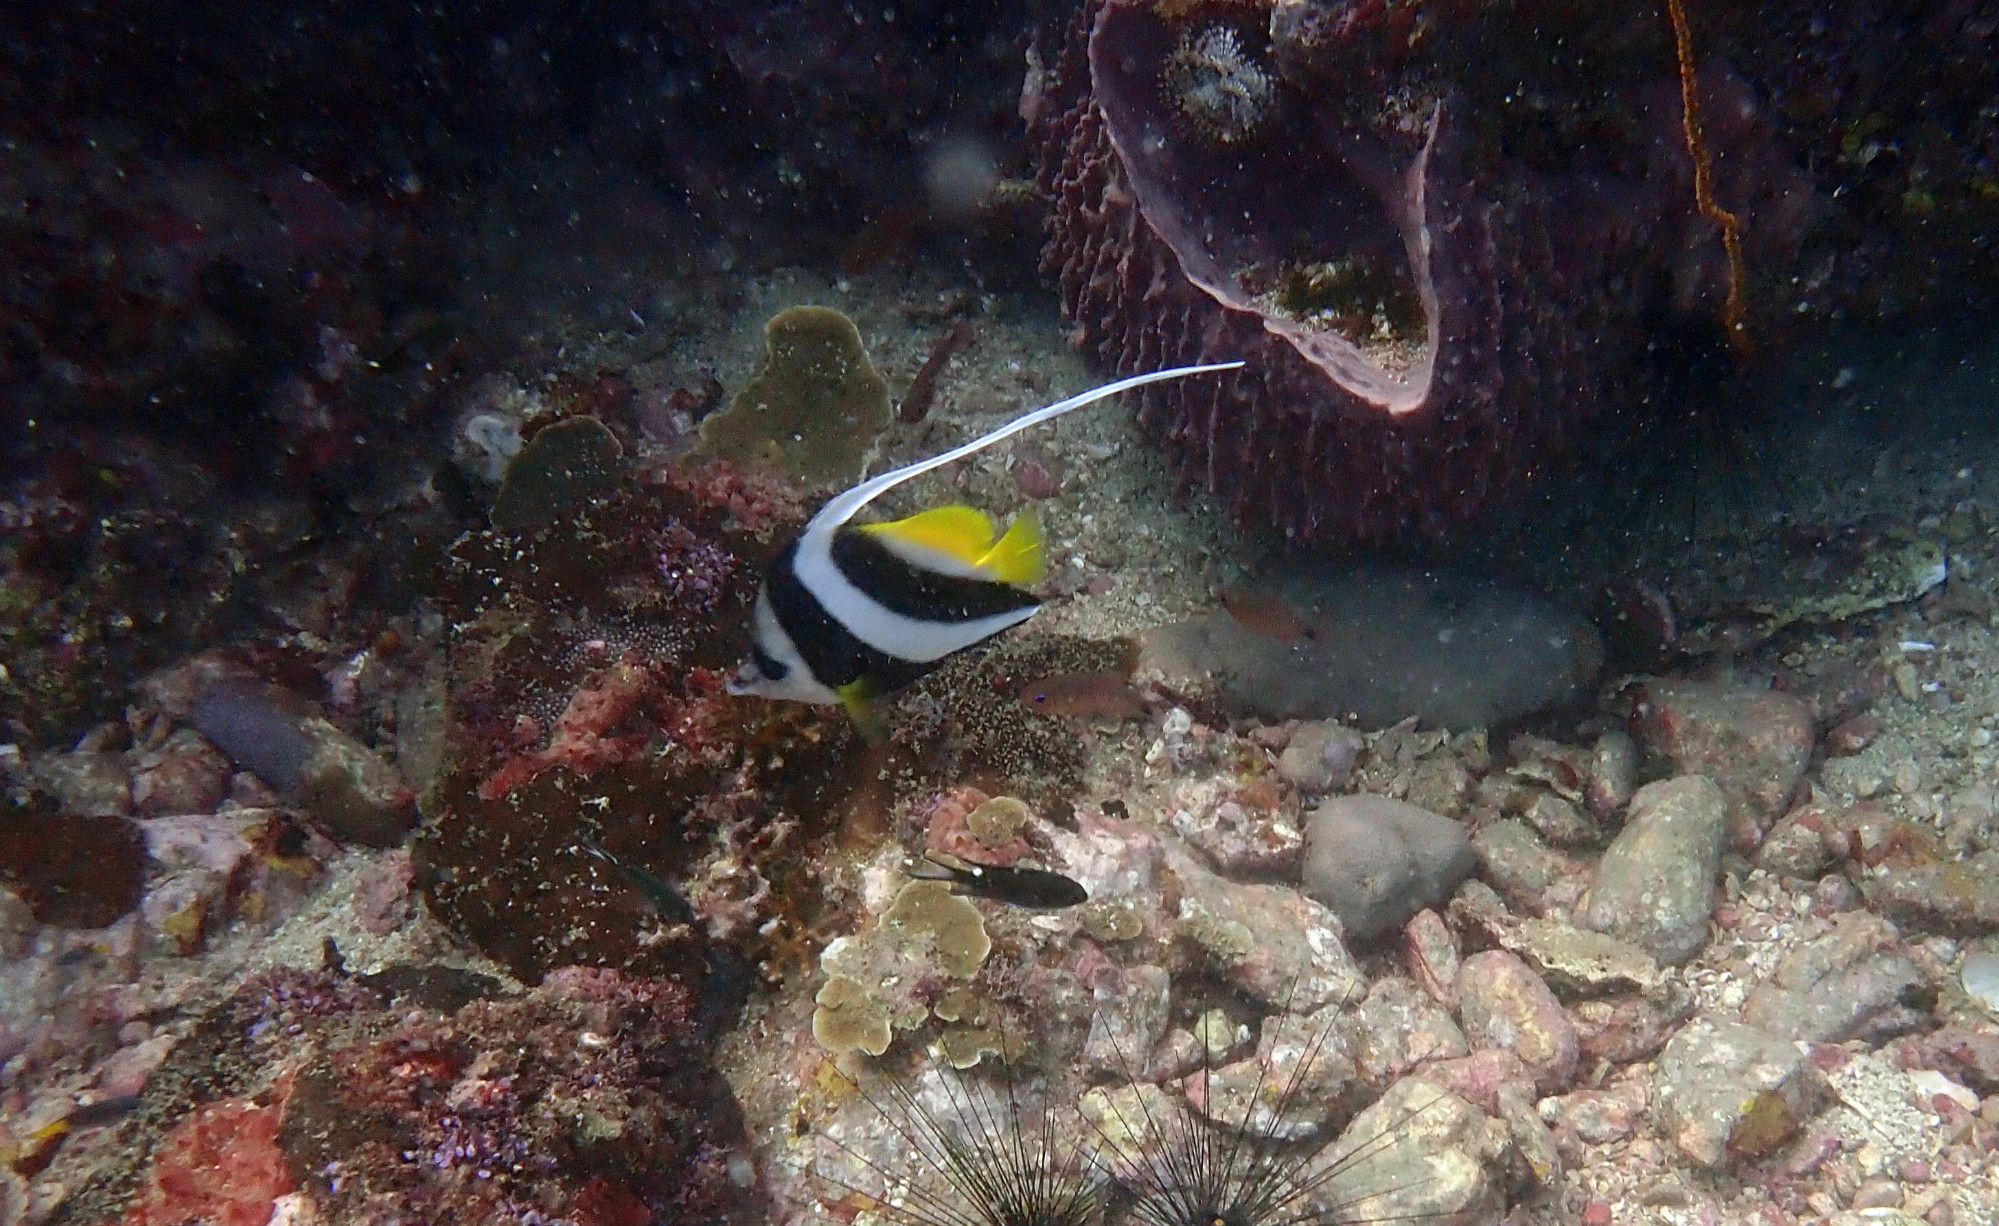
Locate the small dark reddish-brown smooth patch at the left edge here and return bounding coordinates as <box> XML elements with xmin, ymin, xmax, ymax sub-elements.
<box><xmin>0</xmin><ymin>792</ymin><xmax>146</xmax><ymax>928</ymax></box>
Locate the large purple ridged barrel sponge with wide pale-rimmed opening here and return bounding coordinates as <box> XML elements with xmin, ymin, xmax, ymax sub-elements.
<box><xmin>1021</xmin><ymin>0</ymin><xmax>1815</xmax><ymax>542</ymax></box>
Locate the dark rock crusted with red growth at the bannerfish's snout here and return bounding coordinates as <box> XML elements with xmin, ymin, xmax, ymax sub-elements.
<box><xmin>414</xmin><ymin>454</ymin><xmax>860</xmax><ymax>982</ymax></box>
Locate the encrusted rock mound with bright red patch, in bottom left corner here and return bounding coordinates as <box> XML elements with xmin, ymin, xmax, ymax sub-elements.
<box><xmin>50</xmin><ymin>966</ymin><xmax>754</xmax><ymax>1226</ymax></box>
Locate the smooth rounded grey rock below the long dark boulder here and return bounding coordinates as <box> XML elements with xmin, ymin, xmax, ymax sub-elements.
<box><xmin>1305</xmin><ymin>794</ymin><xmax>1477</xmax><ymax>940</ymax></box>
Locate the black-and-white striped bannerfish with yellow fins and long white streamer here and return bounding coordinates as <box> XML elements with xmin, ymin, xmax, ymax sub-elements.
<box><xmin>730</xmin><ymin>362</ymin><xmax>1241</xmax><ymax>728</ymax></box>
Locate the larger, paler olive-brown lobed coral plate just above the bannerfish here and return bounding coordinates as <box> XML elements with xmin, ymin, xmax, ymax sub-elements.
<box><xmin>702</xmin><ymin>306</ymin><xmax>890</xmax><ymax>484</ymax></box>
